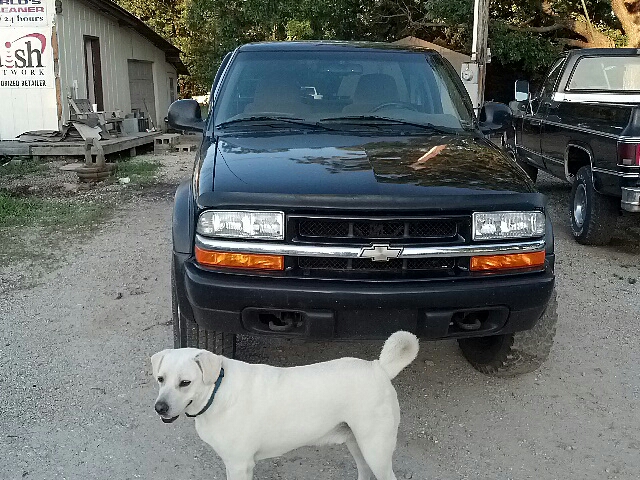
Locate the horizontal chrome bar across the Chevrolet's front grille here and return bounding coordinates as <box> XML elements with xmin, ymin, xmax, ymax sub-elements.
<box><xmin>196</xmin><ymin>235</ymin><xmax>546</xmax><ymax>258</ymax></box>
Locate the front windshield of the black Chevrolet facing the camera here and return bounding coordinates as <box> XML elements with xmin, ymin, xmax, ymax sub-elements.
<box><xmin>214</xmin><ymin>50</ymin><xmax>473</xmax><ymax>130</ymax></box>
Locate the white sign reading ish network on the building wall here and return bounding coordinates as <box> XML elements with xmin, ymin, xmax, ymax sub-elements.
<box><xmin>0</xmin><ymin>28</ymin><xmax>55</xmax><ymax>90</ymax></box>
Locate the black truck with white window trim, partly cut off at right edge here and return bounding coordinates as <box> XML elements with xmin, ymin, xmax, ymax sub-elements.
<box><xmin>506</xmin><ymin>48</ymin><xmax>640</xmax><ymax>245</ymax></box>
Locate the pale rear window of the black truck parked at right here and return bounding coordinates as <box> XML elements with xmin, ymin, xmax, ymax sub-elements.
<box><xmin>568</xmin><ymin>55</ymin><xmax>640</xmax><ymax>92</ymax></box>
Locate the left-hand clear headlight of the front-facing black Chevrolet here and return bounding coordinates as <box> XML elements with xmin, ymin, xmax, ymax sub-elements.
<box><xmin>196</xmin><ymin>210</ymin><xmax>284</xmax><ymax>240</ymax></box>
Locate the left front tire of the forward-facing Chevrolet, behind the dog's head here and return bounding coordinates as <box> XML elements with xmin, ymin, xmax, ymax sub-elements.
<box><xmin>171</xmin><ymin>266</ymin><xmax>237</xmax><ymax>358</ymax></box>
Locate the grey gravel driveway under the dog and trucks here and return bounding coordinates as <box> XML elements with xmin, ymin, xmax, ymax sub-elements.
<box><xmin>0</xmin><ymin>157</ymin><xmax>640</xmax><ymax>480</ymax></box>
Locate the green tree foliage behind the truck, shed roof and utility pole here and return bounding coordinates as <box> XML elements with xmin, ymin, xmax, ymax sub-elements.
<box><xmin>116</xmin><ymin>0</ymin><xmax>640</xmax><ymax>93</ymax></box>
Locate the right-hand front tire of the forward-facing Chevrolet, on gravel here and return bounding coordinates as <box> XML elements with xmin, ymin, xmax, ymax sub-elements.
<box><xmin>458</xmin><ymin>290</ymin><xmax>558</xmax><ymax>377</ymax></box>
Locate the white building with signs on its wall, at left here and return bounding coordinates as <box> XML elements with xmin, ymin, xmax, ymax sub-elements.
<box><xmin>0</xmin><ymin>0</ymin><xmax>187</xmax><ymax>140</ymax></box>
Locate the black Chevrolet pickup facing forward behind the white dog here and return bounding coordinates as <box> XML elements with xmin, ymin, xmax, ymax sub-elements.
<box><xmin>168</xmin><ymin>42</ymin><xmax>557</xmax><ymax>376</ymax></box>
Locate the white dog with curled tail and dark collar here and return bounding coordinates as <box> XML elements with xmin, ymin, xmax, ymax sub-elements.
<box><xmin>151</xmin><ymin>332</ymin><xmax>418</xmax><ymax>480</ymax></box>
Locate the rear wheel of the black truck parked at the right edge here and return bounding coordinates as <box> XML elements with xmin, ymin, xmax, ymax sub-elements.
<box><xmin>571</xmin><ymin>166</ymin><xmax>620</xmax><ymax>245</ymax></box>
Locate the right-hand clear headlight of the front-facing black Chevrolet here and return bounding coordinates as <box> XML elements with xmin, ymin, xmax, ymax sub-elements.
<box><xmin>473</xmin><ymin>212</ymin><xmax>545</xmax><ymax>240</ymax></box>
